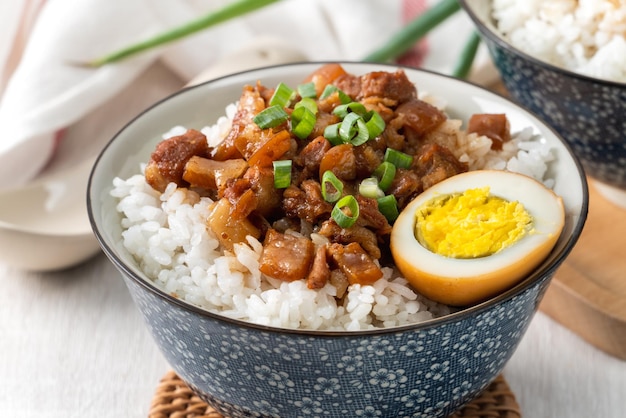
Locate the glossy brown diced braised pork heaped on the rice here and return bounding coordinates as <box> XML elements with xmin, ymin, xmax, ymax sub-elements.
<box><xmin>146</xmin><ymin>64</ymin><xmax>510</xmax><ymax>298</ymax></box>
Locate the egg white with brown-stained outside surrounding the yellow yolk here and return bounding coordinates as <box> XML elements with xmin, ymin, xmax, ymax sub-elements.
<box><xmin>390</xmin><ymin>170</ymin><xmax>565</xmax><ymax>306</ymax></box>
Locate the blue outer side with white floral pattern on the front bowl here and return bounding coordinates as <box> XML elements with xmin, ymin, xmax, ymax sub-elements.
<box><xmin>119</xmin><ymin>268</ymin><xmax>549</xmax><ymax>418</ymax></box>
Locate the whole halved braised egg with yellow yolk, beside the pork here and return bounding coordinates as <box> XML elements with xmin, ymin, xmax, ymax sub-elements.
<box><xmin>391</xmin><ymin>170</ymin><xmax>565</xmax><ymax>306</ymax></box>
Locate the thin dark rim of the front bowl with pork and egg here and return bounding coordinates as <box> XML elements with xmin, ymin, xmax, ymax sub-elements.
<box><xmin>86</xmin><ymin>60</ymin><xmax>589</xmax><ymax>338</ymax></box>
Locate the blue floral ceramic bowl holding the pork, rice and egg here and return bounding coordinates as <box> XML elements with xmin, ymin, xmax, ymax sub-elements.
<box><xmin>88</xmin><ymin>63</ymin><xmax>588</xmax><ymax>417</ymax></box>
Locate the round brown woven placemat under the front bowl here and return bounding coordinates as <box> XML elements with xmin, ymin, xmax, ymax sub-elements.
<box><xmin>148</xmin><ymin>371</ymin><xmax>522</xmax><ymax>418</ymax></box>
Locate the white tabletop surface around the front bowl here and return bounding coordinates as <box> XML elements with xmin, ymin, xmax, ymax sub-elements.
<box><xmin>0</xmin><ymin>62</ymin><xmax>626</xmax><ymax>418</ymax></box>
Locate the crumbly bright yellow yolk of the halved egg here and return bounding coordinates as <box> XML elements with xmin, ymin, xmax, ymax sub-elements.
<box><xmin>415</xmin><ymin>187</ymin><xmax>533</xmax><ymax>258</ymax></box>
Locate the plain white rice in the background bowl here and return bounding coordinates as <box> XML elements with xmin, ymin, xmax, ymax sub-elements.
<box><xmin>493</xmin><ymin>0</ymin><xmax>626</xmax><ymax>82</ymax></box>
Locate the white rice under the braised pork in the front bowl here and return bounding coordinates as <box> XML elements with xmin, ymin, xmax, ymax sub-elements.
<box><xmin>111</xmin><ymin>101</ymin><xmax>552</xmax><ymax>331</ymax></box>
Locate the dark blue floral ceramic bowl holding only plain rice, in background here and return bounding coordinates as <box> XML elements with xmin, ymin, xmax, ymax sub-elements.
<box><xmin>460</xmin><ymin>0</ymin><xmax>626</xmax><ymax>207</ymax></box>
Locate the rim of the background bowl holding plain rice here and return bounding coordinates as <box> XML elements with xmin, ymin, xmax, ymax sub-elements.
<box><xmin>459</xmin><ymin>0</ymin><xmax>626</xmax><ymax>88</ymax></box>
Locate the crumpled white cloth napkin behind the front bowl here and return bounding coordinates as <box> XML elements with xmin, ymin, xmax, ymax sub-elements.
<box><xmin>0</xmin><ymin>0</ymin><xmax>482</xmax><ymax>191</ymax></box>
